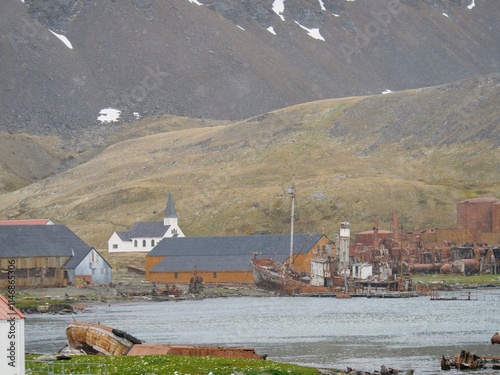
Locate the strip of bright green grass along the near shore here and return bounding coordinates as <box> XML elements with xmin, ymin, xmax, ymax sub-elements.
<box><xmin>26</xmin><ymin>355</ymin><xmax>319</xmax><ymax>375</ymax></box>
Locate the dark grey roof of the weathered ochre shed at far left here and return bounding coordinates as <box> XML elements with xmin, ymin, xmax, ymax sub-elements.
<box><xmin>0</xmin><ymin>225</ymin><xmax>92</xmax><ymax>268</ymax></box>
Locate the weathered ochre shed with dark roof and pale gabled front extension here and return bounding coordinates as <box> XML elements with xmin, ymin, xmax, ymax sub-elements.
<box><xmin>0</xmin><ymin>225</ymin><xmax>111</xmax><ymax>288</ymax></box>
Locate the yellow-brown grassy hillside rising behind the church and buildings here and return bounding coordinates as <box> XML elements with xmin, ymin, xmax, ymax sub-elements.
<box><xmin>0</xmin><ymin>75</ymin><xmax>500</xmax><ymax>248</ymax></box>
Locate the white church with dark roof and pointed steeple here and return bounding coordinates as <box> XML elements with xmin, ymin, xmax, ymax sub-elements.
<box><xmin>108</xmin><ymin>194</ymin><xmax>184</xmax><ymax>253</ymax></box>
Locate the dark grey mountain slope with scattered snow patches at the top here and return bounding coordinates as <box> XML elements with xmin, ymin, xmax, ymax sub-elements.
<box><xmin>0</xmin><ymin>0</ymin><xmax>500</xmax><ymax>138</ymax></box>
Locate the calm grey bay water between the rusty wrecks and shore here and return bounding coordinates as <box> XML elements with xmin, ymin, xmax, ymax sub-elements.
<box><xmin>26</xmin><ymin>289</ymin><xmax>500</xmax><ymax>375</ymax></box>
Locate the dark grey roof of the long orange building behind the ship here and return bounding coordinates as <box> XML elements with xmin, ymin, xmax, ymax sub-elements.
<box><xmin>146</xmin><ymin>234</ymin><xmax>324</xmax><ymax>272</ymax></box>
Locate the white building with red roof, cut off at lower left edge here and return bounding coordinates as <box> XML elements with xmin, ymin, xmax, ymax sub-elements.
<box><xmin>0</xmin><ymin>295</ymin><xmax>25</xmax><ymax>375</ymax></box>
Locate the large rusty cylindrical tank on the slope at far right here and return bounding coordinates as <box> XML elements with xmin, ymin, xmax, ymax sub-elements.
<box><xmin>457</xmin><ymin>197</ymin><xmax>500</xmax><ymax>233</ymax></box>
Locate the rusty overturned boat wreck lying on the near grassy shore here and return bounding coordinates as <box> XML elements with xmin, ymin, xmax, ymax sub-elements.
<box><xmin>66</xmin><ymin>322</ymin><xmax>265</xmax><ymax>359</ymax></box>
